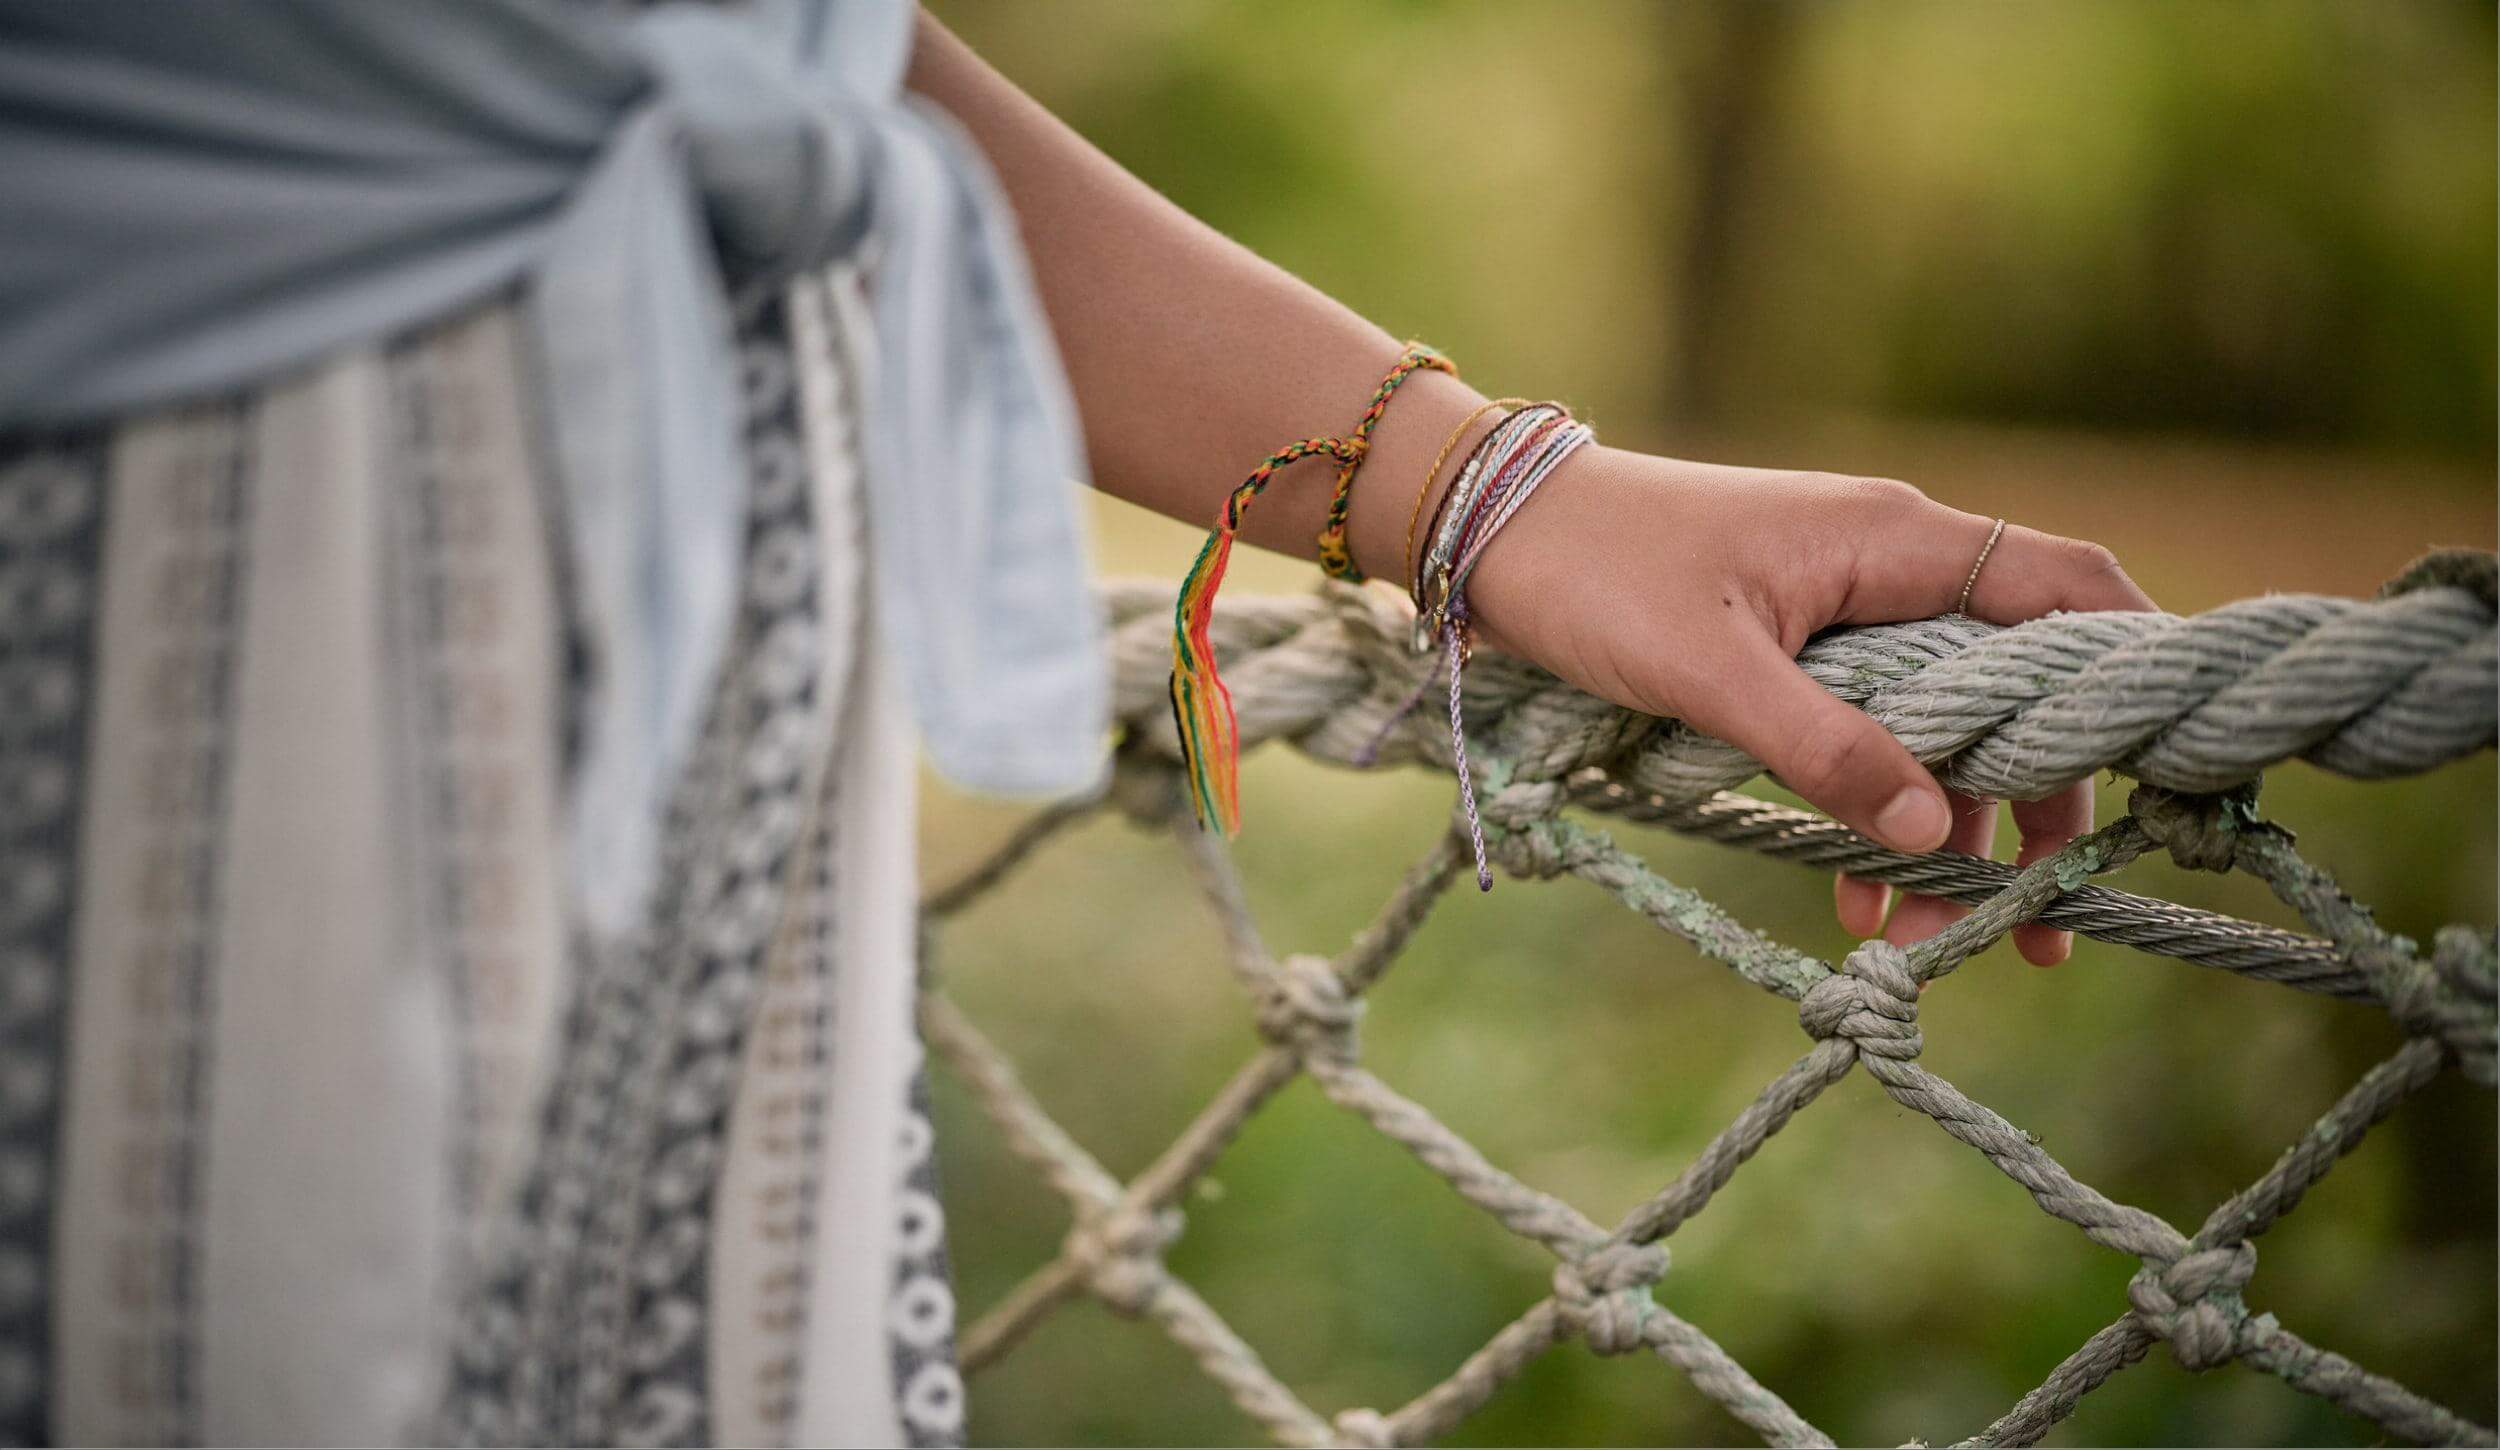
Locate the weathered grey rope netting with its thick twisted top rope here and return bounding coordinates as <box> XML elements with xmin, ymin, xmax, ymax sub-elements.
<box><xmin>923</xmin><ymin>555</ymin><xmax>2500</xmax><ymax>1445</ymax></box>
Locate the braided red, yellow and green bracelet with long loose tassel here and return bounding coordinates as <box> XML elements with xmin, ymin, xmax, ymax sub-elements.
<box><xmin>1170</xmin><ymin>343</ymin><xmax>1458</xmax><ymax>835</ymax></box>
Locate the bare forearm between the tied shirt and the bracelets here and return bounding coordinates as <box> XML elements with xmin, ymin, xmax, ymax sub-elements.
<box><xmin>908</xmin><ymin>13</ymin><xmax>1490</xmax><ymax>578</ymax></box>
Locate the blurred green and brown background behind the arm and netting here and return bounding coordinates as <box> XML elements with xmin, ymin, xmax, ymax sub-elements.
<box><xmin>923</xmin><ymin>0</ymin><xmax>2500</xmax><ymax>1445</ymax></box>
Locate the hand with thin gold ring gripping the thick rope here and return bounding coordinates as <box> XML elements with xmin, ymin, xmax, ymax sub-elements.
<box><xmin>1468</xmin><ymin>448</ymin><xmax>2155</xmax><ymax>965</ymax></box>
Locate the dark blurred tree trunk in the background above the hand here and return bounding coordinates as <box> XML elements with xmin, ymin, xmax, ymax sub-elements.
<box><xmin>1668</xmin><ymin>0</ymin><xmax>1798</xmax><ymax>423</ymax></box>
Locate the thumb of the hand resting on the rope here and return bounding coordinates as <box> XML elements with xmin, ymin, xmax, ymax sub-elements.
<box><xmin>1685</xmin><ymin>638</ymin><xmax>1953</xmax><ymax>853</ymax></box>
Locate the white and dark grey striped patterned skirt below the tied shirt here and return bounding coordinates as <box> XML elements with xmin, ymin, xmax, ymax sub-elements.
<box><xmin>0</xmin><ymin>273</ymin><xmax>963</xmax><ymax>1445</ymax></box>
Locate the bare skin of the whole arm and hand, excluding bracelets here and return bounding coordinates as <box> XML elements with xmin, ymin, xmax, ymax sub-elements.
<box><xmin>908</xmin><ymin>15</ymin><xmax>2153</xmax><ymax>965</ymax></box>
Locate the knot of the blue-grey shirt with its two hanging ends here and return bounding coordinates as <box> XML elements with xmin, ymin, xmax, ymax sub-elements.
<box><xmin>557</xmin><ymin>0</ymin><xmax>1105</xmax><ymax>930</ymax></box>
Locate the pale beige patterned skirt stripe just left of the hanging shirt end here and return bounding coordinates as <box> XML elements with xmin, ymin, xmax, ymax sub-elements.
<box><xmin>388</xmin><ymin>308</ymin><xmax>570</xmax><ymax>1435</ymax></box>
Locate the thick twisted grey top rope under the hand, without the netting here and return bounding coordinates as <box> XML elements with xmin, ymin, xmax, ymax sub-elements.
<box><xmin>1105</xmin><ymin>567</ymin><xmax>2500</xmax><ymax>803</ymax></box>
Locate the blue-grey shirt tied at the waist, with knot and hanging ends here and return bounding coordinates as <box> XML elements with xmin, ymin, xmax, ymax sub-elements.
<box><xmin>0</xmin><ymin>0</ymin><xmax>1108</xmax><ymax>930</ymax></box>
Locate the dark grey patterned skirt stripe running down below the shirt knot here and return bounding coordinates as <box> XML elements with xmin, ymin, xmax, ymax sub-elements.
<box><xmin>453</xmin><ymin>288</ymin><xmax>828</xmax><ymax>1445</ymax></box>
